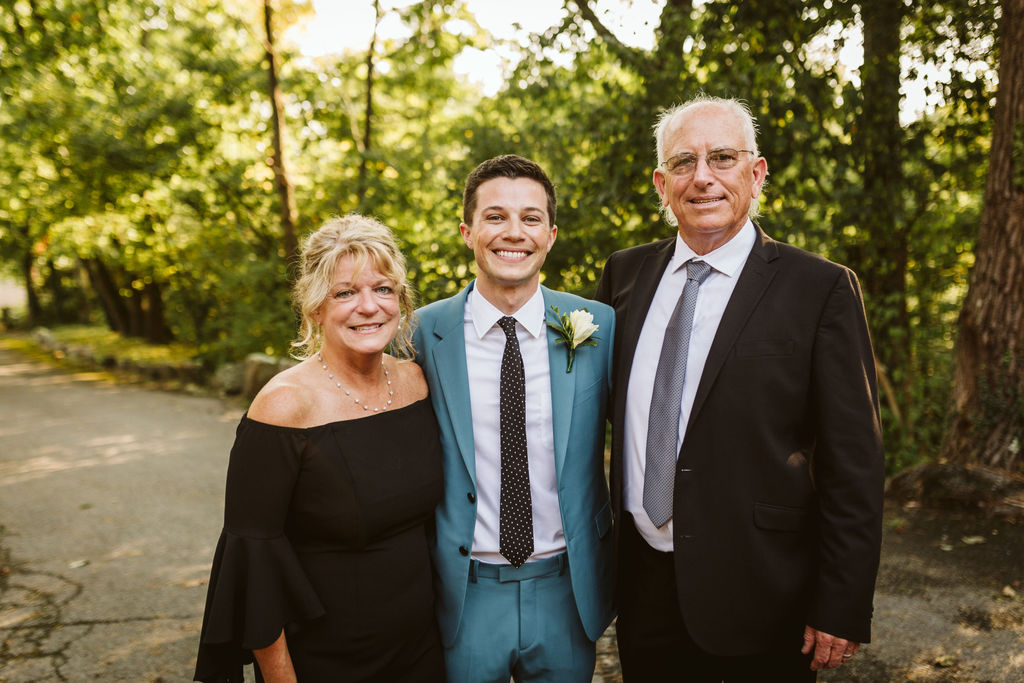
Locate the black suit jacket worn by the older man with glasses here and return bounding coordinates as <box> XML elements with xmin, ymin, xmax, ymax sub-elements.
<box><xmin>597</xmin><ymin>227</ymin><xmax>884</xmax><ymax>655</ymax></box>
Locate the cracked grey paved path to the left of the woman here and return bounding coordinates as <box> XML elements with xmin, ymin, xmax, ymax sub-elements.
<box><xmin>0</xmin><ymin>348</ymin><xmax>241</xmax><ymax>683</ymax></box>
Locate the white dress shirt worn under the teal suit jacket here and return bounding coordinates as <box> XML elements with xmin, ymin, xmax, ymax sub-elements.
<box><xmin>463</xmin><ymin>287</ymin><xmax>565</xmax><ymax>564</ymax></box>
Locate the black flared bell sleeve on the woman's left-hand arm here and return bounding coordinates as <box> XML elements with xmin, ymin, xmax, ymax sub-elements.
<box><xmin>194</xmin><ymin>418</ymin><xmax>325</xmax><ymax>683</ymax></box>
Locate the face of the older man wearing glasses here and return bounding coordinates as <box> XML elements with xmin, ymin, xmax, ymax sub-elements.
<box><xmin>654</xmin><ymin>103</ymin><xmax>768</xmax><ymax>254</ymax></box>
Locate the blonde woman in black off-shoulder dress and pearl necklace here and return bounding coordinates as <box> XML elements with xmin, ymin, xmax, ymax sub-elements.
<box><xmin>196</xmin><ymin>215</ymin><xmax>444</xmax><ymax>683</ymax></box>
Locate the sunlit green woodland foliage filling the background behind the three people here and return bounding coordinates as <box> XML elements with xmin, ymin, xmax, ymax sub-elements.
<box><xmin>0</xmin><ymin>0</ymin><xmax>999</xmax><ymax>470</ymax></box>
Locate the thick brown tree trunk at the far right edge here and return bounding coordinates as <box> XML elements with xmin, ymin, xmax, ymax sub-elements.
<box><xmin>942</xmin><ymin>0</ymin><xmax>1024</xmax><ymax>470</ymax></box>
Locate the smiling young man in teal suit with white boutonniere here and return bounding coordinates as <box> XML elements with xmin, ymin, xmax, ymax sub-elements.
<box><xmin>414</xmin><ymin>155</ymin><xmax>614</xmax><ymax>683</ymax></box>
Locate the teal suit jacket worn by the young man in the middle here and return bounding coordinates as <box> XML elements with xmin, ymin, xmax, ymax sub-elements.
<box><xmin>414</xmin><ymin>283</ymin><xmax>615</xmax><ymax>647</ymax></box>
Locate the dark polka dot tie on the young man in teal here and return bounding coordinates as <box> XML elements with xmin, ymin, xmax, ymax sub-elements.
<box><xmin>498</xmin><ymin>315</ymin><xmax>534</xmax><ymax>567</ymax></box>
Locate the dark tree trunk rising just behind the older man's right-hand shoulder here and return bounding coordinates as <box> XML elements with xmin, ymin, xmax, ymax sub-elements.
<box><xmin>851</xmin><ymin>0</ymin><xmax>912</xmax><ymax>433</ymax></box>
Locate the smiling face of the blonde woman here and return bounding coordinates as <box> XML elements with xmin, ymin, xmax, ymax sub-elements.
<box><xmin>316</xmin><ymin>255</ymin><xmax>401</xmax><ymax>357</ymax></box>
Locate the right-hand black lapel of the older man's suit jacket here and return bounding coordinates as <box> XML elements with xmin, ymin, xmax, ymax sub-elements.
<box><xmin>689</xmin><ymin>227</ymin><xmax>778</xmax><ymax>424</ymax></box>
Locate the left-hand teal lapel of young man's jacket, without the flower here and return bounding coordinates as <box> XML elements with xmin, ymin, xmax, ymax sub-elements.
<box><xmin>431</xmin><ymin>283</ymin><xmax>476</xmax><ymax>485</ymax></box>
